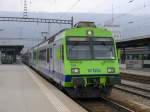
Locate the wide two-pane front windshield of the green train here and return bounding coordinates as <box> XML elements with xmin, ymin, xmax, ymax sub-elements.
<box><xmin>67</xmin><ymin>37</ymin><xmax>115</xmax><ymax>60</ymax></box>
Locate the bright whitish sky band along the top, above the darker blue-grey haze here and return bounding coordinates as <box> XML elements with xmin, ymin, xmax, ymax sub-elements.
<box><xmin>0</xmin><ymin>0</ymin><xmax>150</xmax><ymax>14</ymax></box>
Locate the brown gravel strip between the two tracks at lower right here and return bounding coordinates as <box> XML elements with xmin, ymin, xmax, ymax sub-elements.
<box><xmin>110</xmin><ymin>89</ymin><xmax>150</xmax><ymax>112</ymax></box>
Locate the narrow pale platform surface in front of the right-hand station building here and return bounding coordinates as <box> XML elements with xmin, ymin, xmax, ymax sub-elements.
<box><xmin>121</xmin><ymin>69</ymin><xmax>150</xmax><ymax>77</ymax></box>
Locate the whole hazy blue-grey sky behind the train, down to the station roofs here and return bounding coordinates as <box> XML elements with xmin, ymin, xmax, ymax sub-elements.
<box><xmin>0</xmin><ymin>0</ymin><xmax>150</xmax><ymax>45</ymax></box>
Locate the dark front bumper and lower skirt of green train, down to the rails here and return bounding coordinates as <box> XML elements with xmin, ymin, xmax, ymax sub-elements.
<box><xmin>65</xmin><ymin>75</ymin><xmax>121</xmax><ymax>98</ymax></box>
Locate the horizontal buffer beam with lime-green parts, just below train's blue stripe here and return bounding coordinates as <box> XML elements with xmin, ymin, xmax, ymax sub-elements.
<box><xmin>65</xmin><ymin>74</ymin><xmax>121</xmax><ymax>88</ymax></box>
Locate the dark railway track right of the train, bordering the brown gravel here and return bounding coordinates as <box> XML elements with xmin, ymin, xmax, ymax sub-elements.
<box><xmin>114</xmin><ymin>84</ymin><xmax>150</xmax><ymax>100</ymax></box>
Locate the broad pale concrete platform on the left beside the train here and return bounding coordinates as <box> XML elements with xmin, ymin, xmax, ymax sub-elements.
<box><xmin>0</xmin><ymin>65</ymin><xmax>86</xmax><ymax>112</ymax></box>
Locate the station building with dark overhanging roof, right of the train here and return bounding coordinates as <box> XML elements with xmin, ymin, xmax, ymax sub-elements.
<box><xmin>117</xmin><ymin>35</ymin><xmax>150</xmax><ymax>69</ymax></box>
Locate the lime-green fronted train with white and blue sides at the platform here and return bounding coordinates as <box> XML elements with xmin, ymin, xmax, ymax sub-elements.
<box><xmin>24</xmin><ymin>22</ymin><xmax>121</xmax><ymax>98</ymax></box>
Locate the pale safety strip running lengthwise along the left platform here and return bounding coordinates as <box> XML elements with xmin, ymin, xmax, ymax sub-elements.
<box><xmin>24</xmin><ymin>66</ymin><xmax>70</xmax><ymax>112</ymax></box>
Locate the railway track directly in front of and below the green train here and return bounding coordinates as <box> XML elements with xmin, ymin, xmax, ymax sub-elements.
<box><xmin>75</xmin><ymin>98</ymin><xmax>135</xmax><ymax>112</ymax></box>
